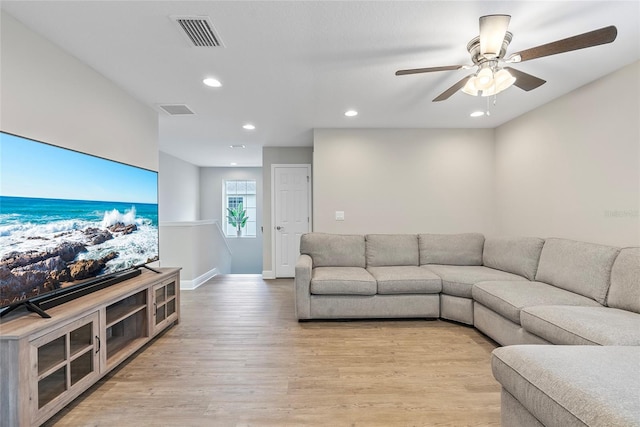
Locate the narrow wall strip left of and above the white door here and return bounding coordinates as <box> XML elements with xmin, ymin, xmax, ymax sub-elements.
<box><xmin>262</xmin><ymin>147</ymin><xmax>313</xmax><ymax>277</ymax></box>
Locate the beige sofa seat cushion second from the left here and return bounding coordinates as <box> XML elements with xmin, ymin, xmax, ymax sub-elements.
<box><xmin>367</xmin><ymin>266</ymin><xmax>442</xmax><ymax>294</ymax></box>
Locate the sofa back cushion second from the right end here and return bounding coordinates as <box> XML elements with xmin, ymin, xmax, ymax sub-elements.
<box><xmin>536</xmin><ymin>238</ymin><xmax>620</xmax><ymax>305</ymax></box>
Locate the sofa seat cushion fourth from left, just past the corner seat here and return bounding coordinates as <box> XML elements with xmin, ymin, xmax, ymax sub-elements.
<box><xmin>473</xmin><ymin>281</ymin><xmax>601</xmax><ymax>325</ymax></box>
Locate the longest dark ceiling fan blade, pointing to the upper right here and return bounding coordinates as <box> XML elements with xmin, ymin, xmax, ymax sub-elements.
<box><xmin>509</xmin><ymin>25</ymin><xmax>618</xmax><ymax>62</ymax></box>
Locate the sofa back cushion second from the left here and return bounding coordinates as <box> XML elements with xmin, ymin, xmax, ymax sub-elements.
<box><xmin>365</xmin><ymin>234</ymin><xmax>420</xmax><ymax>267</ymax></box>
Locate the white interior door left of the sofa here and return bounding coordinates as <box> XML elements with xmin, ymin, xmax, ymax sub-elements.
<box><xmin>273</xmin><ymin>165</ymin><xmax>311</xmax><ymax>277</ymax></box>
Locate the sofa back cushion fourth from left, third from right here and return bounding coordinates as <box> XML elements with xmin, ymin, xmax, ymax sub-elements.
<box><xmin>482</xmin><ymin>237</ymin><xmax>544</xmax><ymax>280</ymax></box>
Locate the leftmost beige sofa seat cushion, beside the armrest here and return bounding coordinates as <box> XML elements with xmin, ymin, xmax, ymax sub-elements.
<box><xmin>311</xmin><ymin>267</ymin><xmax>377</xmax><ymax>295</ymax></box>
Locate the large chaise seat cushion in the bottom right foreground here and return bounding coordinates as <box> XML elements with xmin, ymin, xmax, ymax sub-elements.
<box><xmin>491</xmin><ymin>345</ymin><xmax>640</xmax><ymax>426</ymax></box>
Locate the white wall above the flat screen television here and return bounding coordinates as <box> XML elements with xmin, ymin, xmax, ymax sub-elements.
<box><xmin>0</xmin><ymin>11</ymin><xmax>158</xmax><ymax>171</ymax></box>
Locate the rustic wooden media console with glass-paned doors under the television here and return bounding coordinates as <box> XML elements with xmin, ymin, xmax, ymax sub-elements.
<box><xmin>0</xmin><ymin>268</ymin><xmax>180</xmax><ymax>427</ymax></box>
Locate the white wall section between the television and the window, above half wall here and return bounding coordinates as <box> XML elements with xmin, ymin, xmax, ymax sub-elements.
<box><xmin>158</xmin><ymin>151</ymin><xmax>200</xmax><ymax>222</ymax></box>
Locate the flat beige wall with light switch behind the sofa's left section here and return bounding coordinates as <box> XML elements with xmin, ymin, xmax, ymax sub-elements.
<box><xmin>313</xmin><ymin>129</ymin><xmax>495</xmax><ymax>234</ymax></box>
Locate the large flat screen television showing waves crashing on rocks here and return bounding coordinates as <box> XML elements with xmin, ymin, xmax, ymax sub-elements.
<box><xmin>0</xmin><ymin>132</ymin><xmax>159</xmax><ymax>316</ymax></box>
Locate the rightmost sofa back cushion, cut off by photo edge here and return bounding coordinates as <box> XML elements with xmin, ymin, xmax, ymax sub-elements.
<box><xmin>607</xmin><ymin>248</ymin><xmax>640</xmax><ymax>313</ymax></box>
